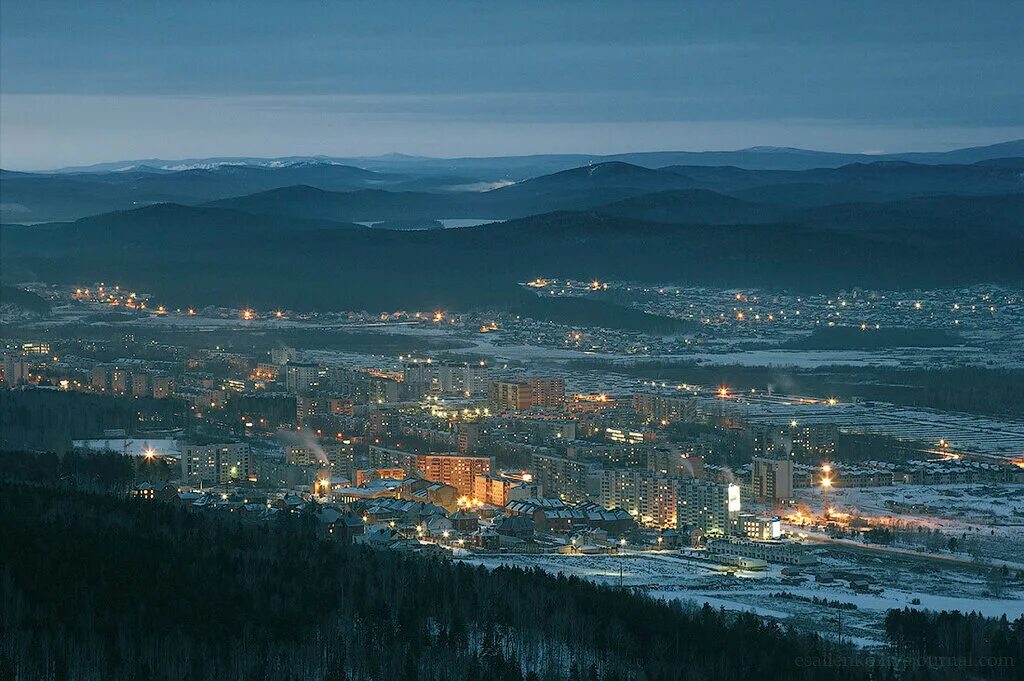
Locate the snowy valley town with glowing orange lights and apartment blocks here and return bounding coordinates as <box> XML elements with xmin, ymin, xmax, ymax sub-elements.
<box><xmin>3</xmin><ymin>281</ymin><xmax>1024</xmax><ymax>645</ymax></box>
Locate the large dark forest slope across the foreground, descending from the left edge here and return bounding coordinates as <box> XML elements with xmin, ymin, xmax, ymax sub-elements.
<box><xmin>0</xmin><ymin>481</ymin><xmax>880</xmax><ymax>681</ymax></box>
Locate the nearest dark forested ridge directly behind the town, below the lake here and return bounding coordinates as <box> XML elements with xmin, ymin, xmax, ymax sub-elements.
<box><xmin>0</xmin><ymin>199</ymin><xmax>1024</xmax><ymax>309</ymax></box>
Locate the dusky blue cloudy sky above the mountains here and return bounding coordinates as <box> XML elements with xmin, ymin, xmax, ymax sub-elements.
<box><xmin>0</xmin><ymin>0</ymin><xmax>1024</xmax><ymax>169</ymax></box>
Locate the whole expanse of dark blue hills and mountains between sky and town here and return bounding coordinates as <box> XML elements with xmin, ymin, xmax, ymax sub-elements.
<box><xmin>0</xmin><ymin>142</ymin><xmax>1024</xmax><ymax>311</ymax></box>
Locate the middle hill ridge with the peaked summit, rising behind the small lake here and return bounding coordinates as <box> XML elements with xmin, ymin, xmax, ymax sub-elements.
<box><xmin>201</xmin><ymin>160</ymin><xmax>1024</xmax><ymax>223</ymax></box>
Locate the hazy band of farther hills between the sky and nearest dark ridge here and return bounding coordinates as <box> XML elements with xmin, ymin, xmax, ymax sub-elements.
<box><xmin>6</xmin><ymin>151</ymin><xmax>1024</xmax><ymax>223</ymax></box>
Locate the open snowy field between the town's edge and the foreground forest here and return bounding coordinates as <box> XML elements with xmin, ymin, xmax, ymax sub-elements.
<box><xmin>460</xmin><ymin>547</ymin><xmax>1024</xmax><ymax>646</ymax></box>
